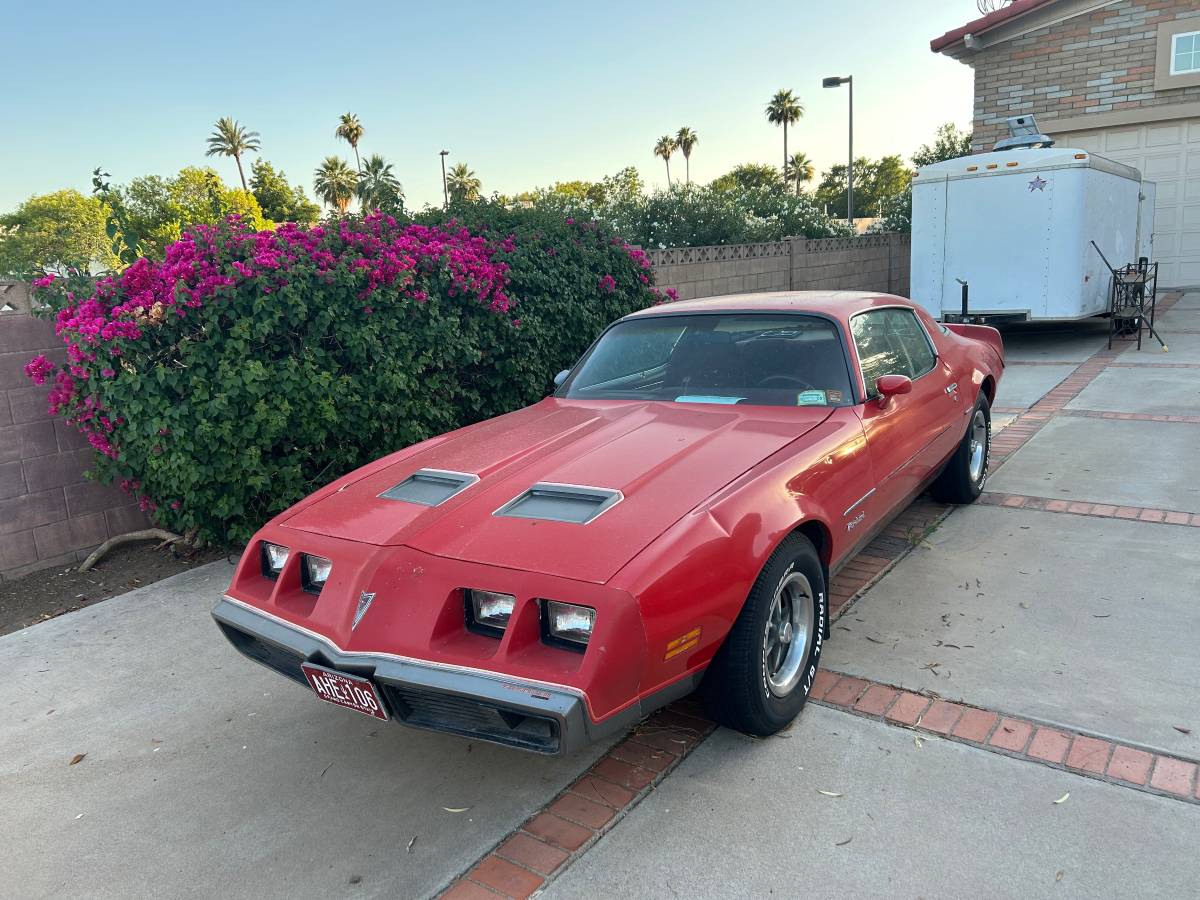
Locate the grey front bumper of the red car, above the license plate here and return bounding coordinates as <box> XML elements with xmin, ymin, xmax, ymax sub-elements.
<box><xmin>212</xmin><ymin>596</ymin><xmax>642</xmax><ymax>754</ymax></box>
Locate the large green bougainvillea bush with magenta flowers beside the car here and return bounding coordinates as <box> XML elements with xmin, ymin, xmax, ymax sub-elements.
<box><xmin>26</xmin><ymin>211</ymin><xmax>660</xmax><ymax>544</ymax></box>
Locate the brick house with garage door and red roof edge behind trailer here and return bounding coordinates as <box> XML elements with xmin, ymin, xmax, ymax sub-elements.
<box><xmin>930</xmin><ymin>0</ymin><xmax>1200</xmax><ymax>287</ymax></box>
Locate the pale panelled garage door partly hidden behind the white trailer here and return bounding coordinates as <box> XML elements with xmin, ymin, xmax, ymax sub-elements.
<box><xmin>1058</xmin><ymin>119</ymin><xmax>1200</xmax><ymax>287</ymax></box>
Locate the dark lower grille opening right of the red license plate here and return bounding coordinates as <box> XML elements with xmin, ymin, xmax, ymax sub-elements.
<box><xmin>380</xmin><ymin>684</ymin><xmax>560</xmax><ymax>754</ymax></box>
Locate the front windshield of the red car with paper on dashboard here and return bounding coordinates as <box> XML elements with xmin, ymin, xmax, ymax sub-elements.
<box><xmin>558</xmin><ymin>313</ymin><xmax>853</xmax><ymax>407</ymax></box>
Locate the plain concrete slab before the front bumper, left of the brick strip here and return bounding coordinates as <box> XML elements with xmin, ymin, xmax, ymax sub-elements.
<box><xmin>0</xmin><ymin>562</ymin><xmax>604</xmax><ymax>899</ymax></box>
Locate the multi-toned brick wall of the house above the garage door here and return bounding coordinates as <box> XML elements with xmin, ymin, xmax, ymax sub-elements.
<box><xmin>946</xmin><ymin>0</ymin><xmax>1200</xmax><ymax>152</ymax></box>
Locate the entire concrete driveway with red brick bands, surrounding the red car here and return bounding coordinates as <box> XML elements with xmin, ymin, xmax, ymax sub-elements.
<box><xmin>0</xmin><ymin>295</ymin><xmax>1200</xmax><ymax>900</ymax></box>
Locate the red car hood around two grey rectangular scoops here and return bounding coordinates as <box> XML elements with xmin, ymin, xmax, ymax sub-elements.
<box><xmin>282</xmin><ymin>398</ymin><xmax>830</xmax><ymax>583</ymax></box>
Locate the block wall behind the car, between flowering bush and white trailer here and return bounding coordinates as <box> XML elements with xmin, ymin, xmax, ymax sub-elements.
<box><xmin>649</xmin><ymin>234</ymin><xmax>910</xmax><ymax>300</ymax></box>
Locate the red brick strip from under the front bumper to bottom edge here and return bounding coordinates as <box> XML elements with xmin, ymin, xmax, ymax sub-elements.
<box><xmin>440</xmin><ymin>700</ymin><xmax>716</xmax><ymax>900</ymax></box>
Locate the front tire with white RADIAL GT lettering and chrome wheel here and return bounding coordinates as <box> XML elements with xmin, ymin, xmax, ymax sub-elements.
<box><xmin>701</xmin><ymin>534</ymin><xmax>827</xmax><ymax>737</ymax></box>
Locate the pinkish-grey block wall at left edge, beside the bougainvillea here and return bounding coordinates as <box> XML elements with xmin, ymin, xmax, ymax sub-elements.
<box><xmin>0</xmin><ymin>281</ymin><xmax>146</xmax><ymax>580</ymax></box>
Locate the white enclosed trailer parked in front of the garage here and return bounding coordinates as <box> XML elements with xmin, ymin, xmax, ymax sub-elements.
<box><xmin>911</xmin><ymin>146</ymin><xmax>1154</xmax><ymax>322</ymax></box>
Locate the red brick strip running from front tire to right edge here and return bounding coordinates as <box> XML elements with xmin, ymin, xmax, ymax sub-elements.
<box><xmin>809</xmin><ymin>670</ymin><xmax>1200</xmax><ymax>803</ymax></box>
